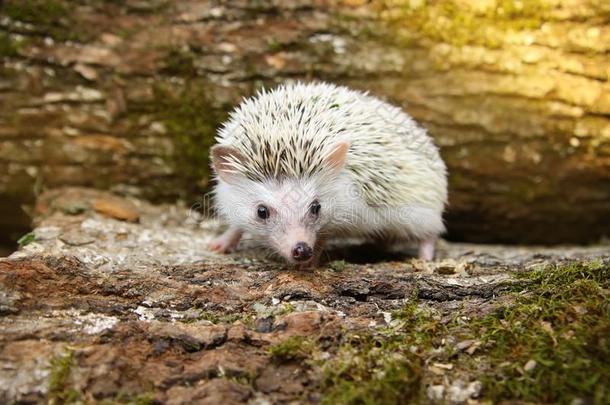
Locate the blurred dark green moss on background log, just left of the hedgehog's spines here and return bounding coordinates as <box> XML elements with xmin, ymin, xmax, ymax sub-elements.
<box><xmin>154</xmin><ymin>81</ymin><xmax>226</xmax><ymax>194</ymax></box>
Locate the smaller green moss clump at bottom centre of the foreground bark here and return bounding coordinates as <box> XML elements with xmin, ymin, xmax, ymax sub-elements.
<box><xmin>322</xmin><ymin>294</ymin><xmax>445</xmax><ymax>404</ymax></box>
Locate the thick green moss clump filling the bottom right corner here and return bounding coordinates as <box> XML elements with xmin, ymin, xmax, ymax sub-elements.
<box><xmin>472</xmin><ymin>263</ymin><xmax>610</xmax><ymax>404</ymax></box>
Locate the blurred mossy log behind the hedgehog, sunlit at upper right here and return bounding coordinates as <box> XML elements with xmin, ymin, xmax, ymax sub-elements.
<box><xmin>0</xmin><ymin>0</ymin><xmax>610</xmax><ymax>253</ymax></box>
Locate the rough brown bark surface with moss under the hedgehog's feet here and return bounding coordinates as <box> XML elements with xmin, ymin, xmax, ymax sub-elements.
<box><xmin>0</xmin><ymin>189</ymin><xmax>610</xmax><ymax>405</ymax></box>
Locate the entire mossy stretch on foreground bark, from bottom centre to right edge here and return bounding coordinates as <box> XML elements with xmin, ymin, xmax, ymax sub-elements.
<box><xmin>260</xmin><ymin>262</ymin><xmax>610</xmax><ymax>404</ymax></box>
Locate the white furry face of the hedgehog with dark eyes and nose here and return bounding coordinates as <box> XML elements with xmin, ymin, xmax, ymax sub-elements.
<box><xmin>214</xmin><ymin>142</ymin><xmax>347</xmax><ymax>265</ymax></box>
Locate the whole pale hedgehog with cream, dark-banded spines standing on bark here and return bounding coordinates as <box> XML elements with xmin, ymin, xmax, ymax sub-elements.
<box><xmin>209</xmin><ymin>82</ymin><xmax>447</xmax><ymax>267</ymax></box>
